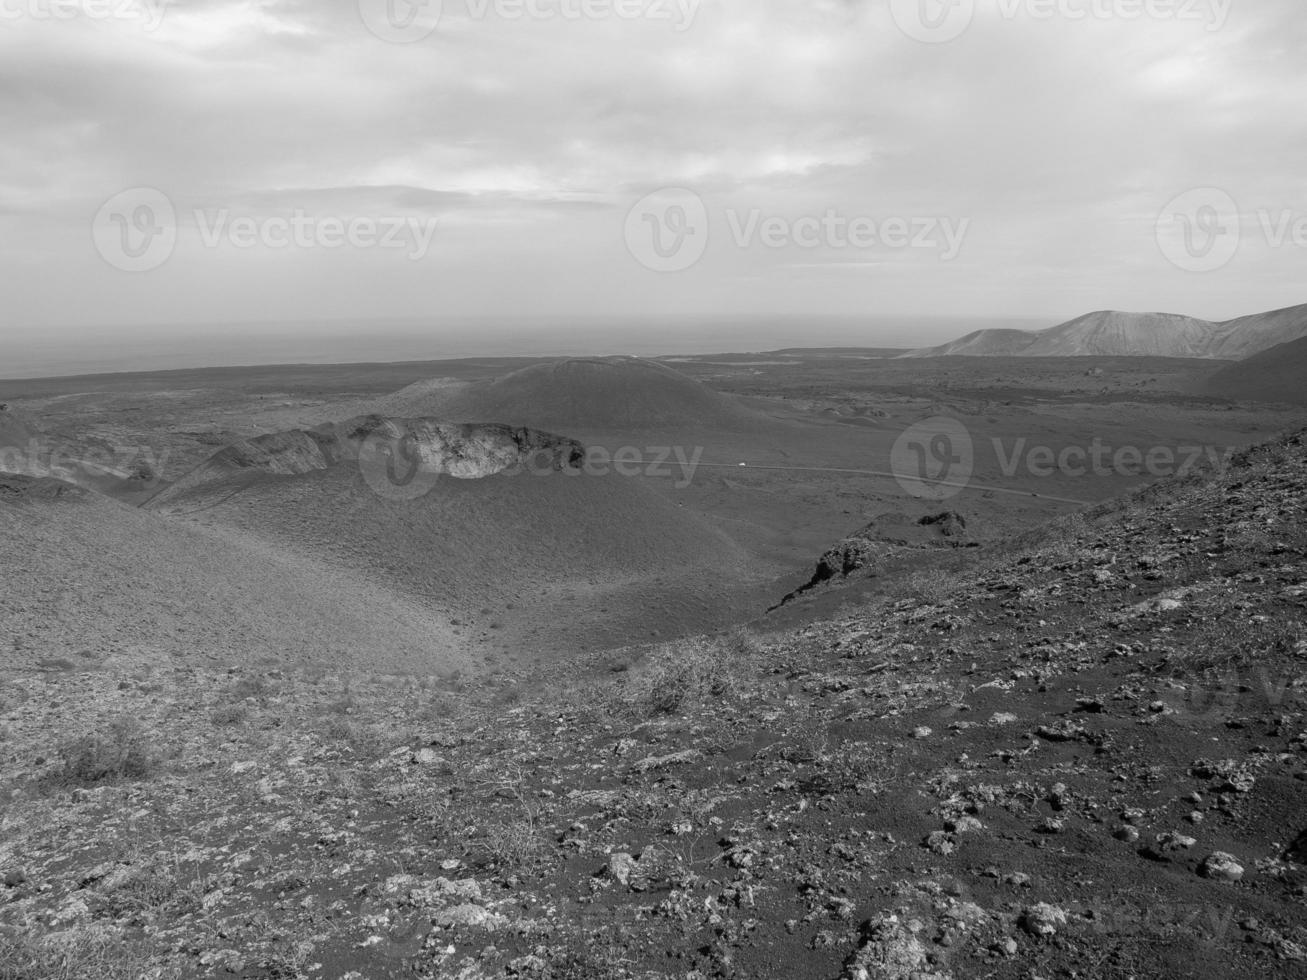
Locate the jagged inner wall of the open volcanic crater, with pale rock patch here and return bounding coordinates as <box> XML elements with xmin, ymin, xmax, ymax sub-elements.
<box><xmin>149</xmin><ymin>416</ymin><xmax>586</xmax><ymax>507</ymax></box>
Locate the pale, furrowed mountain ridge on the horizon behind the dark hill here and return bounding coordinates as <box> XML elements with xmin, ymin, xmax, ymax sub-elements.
<box><xmin>904</xmin><ymin>304</ymin><xmax>1307</xmax><ymax>361</ymax></box>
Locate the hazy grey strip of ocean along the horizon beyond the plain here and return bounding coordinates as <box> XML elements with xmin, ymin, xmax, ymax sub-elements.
<box><xmin>0</xmin><ymin>316</ymin><xmax>1053</xmax><ymax>379</ymax></box>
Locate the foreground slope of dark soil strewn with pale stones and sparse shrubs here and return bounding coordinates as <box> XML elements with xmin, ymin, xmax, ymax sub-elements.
<box><xmin>0</xmin><ymin>435</ymin><xmax>1307</xmax><ymax>980</ymax></box>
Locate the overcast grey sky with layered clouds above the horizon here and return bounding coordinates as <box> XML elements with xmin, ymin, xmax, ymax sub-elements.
<box><xmin>0</xmin><ymin>0</ymin><xmax>1307</xmax><ymax>376</ymax></box>
